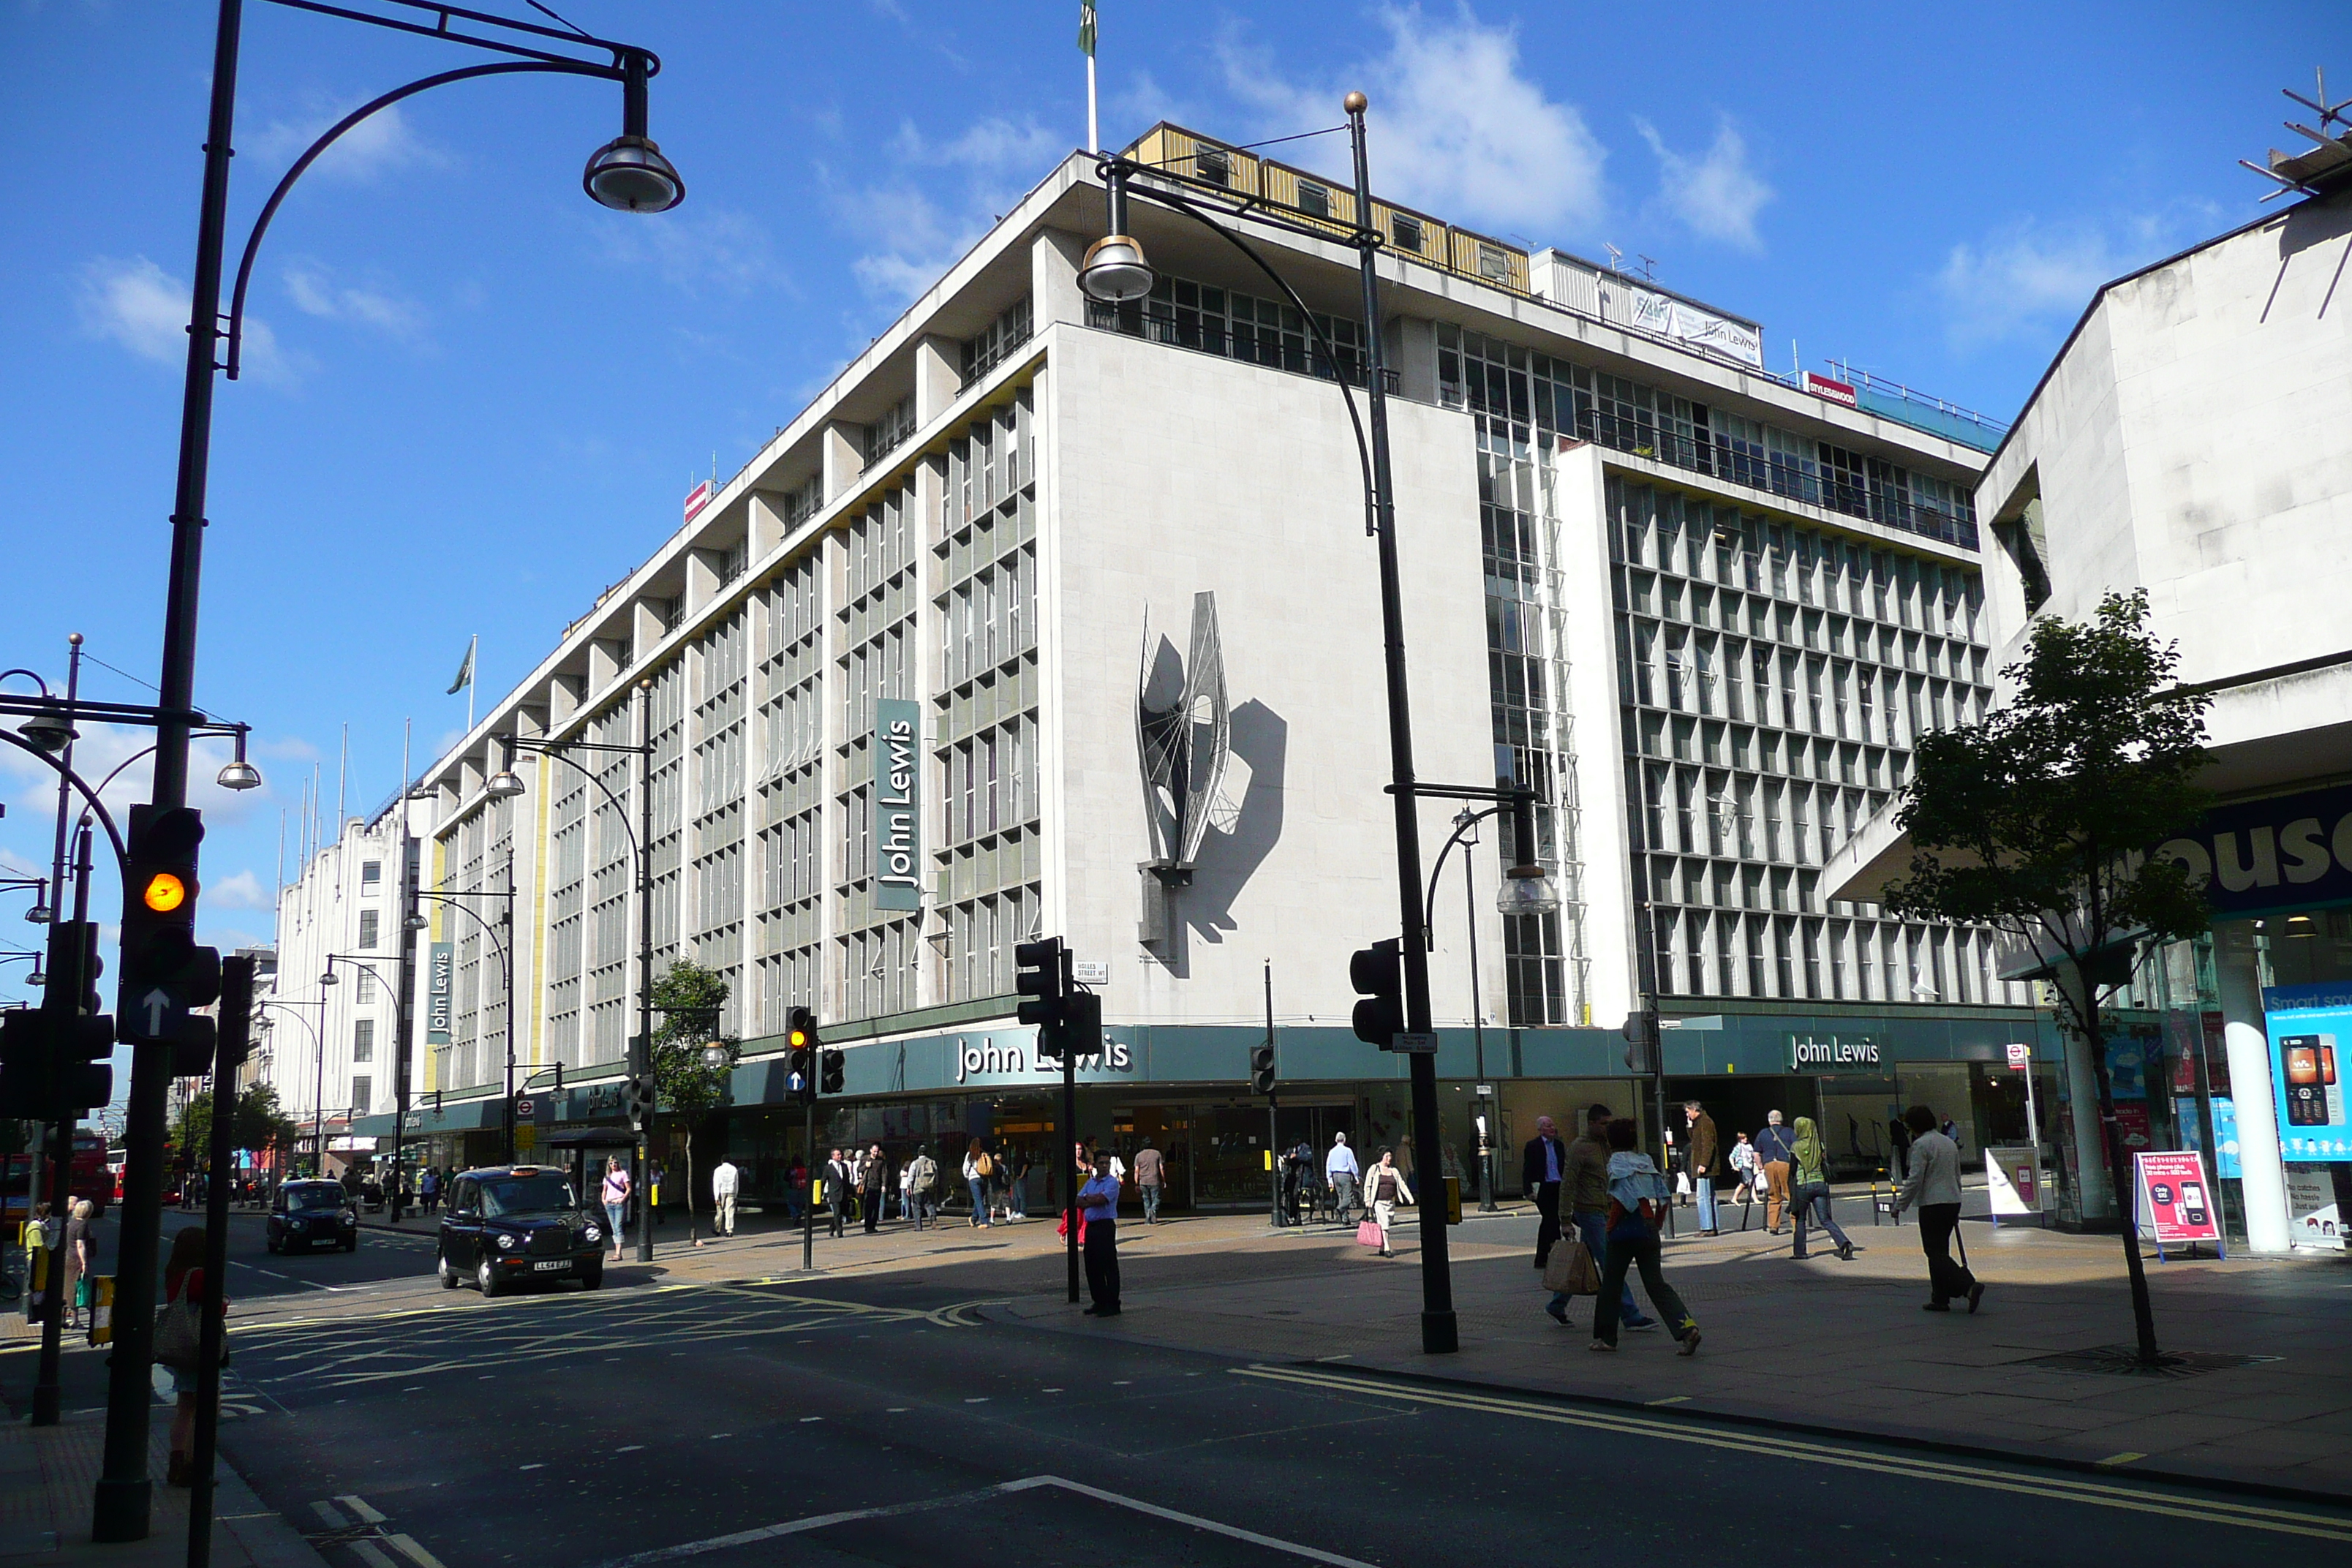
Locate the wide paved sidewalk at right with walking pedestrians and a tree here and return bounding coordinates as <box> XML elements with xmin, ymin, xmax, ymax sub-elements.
<box><xmin>992</xmin><ymin>1222</ymin><xmax>2352</xmax><ymax>1500</ymax></box>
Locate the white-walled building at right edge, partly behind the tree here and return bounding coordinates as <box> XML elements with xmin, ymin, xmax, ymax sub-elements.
<box><xmin>1830</xmin><ymin>116</ymin><xmax>2352</xmax><ymax>1251</ymax></box>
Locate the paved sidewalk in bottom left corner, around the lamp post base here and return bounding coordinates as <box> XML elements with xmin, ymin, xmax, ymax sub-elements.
<box><xmin>0</xmin><ymin>1408</ymin><xmax>325</xmax><ymax>1568</ymax></box>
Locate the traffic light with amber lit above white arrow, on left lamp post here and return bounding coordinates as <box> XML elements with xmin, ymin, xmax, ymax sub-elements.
<box><xmin>116</xmin><ymin>807</ymin><xmax>221</xmax><ymax>1077</ymax></box>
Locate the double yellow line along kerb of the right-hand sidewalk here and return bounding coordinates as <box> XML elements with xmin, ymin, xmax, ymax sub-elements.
<box><xmin>1228</xmin><ymin>1363</ymin><xmax>2352</xmax><ymax>1542</ymax></box>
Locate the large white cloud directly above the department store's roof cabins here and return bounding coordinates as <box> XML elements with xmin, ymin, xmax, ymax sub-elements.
<box><xmin>1221</xmin><ymin>4</ymin><xmax>1609</xmax><ymax>238</ymax></box>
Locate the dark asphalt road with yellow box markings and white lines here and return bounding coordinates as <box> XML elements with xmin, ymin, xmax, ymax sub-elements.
<box><xmin>7</xmin><ymin>1220</ymin><xmax>2352</xmax><ymax>1568</ymax></box>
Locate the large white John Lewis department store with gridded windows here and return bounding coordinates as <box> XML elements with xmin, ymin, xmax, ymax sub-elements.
<box><xmin>372</xmin><ymin>127</ymin><xmax>2060</xmax><ymax>1202</ymax></box>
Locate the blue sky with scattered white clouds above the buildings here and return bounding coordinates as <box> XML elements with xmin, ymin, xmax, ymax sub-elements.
<box><xmin>0</xmin><ymin>0</ymin><xmax>2352</xmax><ymax>1020</ymax></box>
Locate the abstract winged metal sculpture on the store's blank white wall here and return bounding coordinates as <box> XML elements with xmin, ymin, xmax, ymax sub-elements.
<box><xmin>1136</xmin><ymin>592</ymin><xmax>1232</xmax><ymax>943</ymax></box>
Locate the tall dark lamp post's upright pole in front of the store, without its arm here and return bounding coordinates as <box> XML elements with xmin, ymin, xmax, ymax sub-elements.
<box><xmin>1348</xmin><ymin>94</ymin><xmax>1460</xmax><ymax>1354</ymax></box>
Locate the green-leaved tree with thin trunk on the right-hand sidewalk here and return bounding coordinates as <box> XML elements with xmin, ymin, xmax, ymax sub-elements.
<box><xmin>1882</xmin><ymin>590</ymin><xmax>2211</xmax><ymax>1363</ymax></box>
